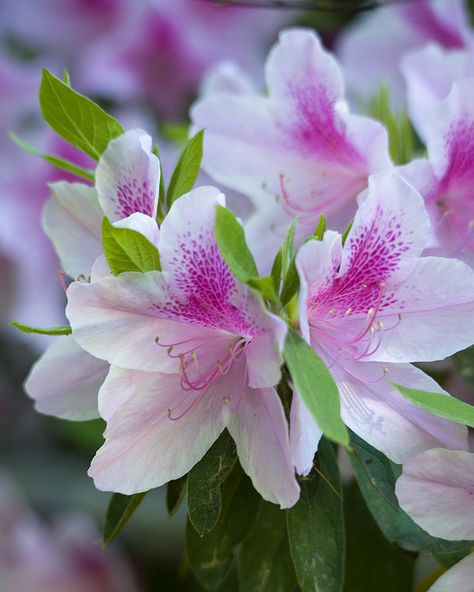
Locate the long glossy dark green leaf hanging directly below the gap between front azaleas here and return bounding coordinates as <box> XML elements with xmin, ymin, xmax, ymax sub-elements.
<box><xmin>287</xmin><ymin>438</ymin><xmax>345</xmax><ymax>592</ymax></box>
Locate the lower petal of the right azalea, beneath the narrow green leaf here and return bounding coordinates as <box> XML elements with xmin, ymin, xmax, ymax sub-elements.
<box><xmin>332</xmin><ymin>362</ymin><xmax>467</xmax><ymax>463</ymax></box>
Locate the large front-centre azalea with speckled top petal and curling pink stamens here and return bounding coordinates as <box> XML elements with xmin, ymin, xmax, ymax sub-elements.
<box><xmin>67</xmin><ymin>187</ymin><xmax>299</xmax><ymax>507</ymax></box>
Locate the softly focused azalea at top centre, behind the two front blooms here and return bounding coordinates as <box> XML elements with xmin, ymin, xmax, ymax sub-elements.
<box><xmin>191</xmin><ymin>29</ymin><xmax>390</xmax><ymax>272</ymax></box>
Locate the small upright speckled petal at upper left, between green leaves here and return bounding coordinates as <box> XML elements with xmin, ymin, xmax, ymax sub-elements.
<box><xmin>96</xmin><ymin>130</ymin><xmax>160</xmax><ymax>222</ymax></box>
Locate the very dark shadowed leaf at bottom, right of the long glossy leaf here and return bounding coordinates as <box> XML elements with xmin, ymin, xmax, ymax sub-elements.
<box><xmin>344</xmin><ymin>482</ymin><xmax>415</xmax><ymax>592</ymax></box>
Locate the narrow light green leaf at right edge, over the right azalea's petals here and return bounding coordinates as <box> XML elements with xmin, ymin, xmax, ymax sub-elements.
<box><xmin>393</xmin><ymin>384</ymin><xmax>474</xmax><ymax>428</ymax></box>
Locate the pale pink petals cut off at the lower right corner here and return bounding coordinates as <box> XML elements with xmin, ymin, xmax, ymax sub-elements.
<box><xmin>395</xmin><ymin>448</ymin><xmax>474</xmax><ymax>592</ymax></box>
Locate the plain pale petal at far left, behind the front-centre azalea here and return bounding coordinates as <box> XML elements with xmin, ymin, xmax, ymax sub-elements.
<box><xmin>25</xmin><ymin>335</ymin><xmax>109</xmax><ymax>421</ymax></box>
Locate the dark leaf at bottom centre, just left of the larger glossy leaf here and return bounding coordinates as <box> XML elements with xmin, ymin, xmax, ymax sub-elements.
<box><xmin>240</xmin><ymin>500</ymin><xmax>297</xmax><ymax>592</ymax></box>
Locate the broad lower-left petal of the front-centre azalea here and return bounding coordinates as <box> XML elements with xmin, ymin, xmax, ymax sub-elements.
<box><xmin>89</xmin><ymin>371</ymin><xmax>232</xmax><ymax>495</ymax></box>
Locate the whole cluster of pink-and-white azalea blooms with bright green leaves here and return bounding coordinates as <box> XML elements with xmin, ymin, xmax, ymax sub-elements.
<box><xmin>14</xmin><ymin>1</ymin><xmax>474</xmax><ymax>592</ymax></box>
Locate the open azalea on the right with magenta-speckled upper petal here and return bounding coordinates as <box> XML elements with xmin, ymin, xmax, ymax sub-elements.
<box><xmin>292</xmin><ymin>173</ymin><xmax>474</xmax><ymax>473</ymax></box>
